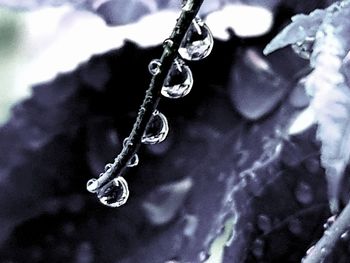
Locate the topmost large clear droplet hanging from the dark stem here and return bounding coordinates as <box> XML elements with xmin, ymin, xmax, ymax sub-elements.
<box><xmin>179</xmin><ymin>18</ymin><xmax>214</xmax><ymax>61</ymax></box>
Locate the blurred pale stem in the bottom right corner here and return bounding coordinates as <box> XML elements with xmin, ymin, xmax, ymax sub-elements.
<box><xmin>302</xmin><ymin>203</ymin><xmax>350</xmax><ymax>263</ymax></box>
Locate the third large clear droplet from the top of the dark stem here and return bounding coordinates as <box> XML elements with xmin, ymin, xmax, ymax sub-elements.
<box><xmin>141</xmin><ymin>110</ymin><xmax>169</xmax><ymax>144</ymax></box>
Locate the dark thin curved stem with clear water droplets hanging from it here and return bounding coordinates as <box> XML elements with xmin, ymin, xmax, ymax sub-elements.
<box><xmin>91</xmin><ymin>0</ymin><xmax>204</xmax><ymax>194</ymax></box>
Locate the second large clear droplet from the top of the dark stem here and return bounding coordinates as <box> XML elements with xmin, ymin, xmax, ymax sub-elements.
<box><xmin>161</xmin><ymin>59</ymin><xmax>193</xmax><ymax>99</ymax></box>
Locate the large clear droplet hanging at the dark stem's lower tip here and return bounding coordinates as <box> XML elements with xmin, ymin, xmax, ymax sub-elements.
<box><xmin>97</xmin><ymin>176</ymin><xmax>129</xmax><ymax>207</ymax></box>
